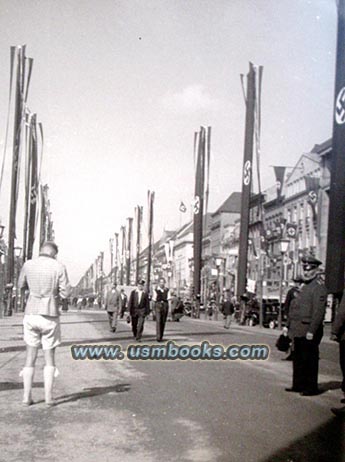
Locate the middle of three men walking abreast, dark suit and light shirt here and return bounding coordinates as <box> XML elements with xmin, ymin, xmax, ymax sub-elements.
<box><xmin>128</xmin><ymin>279</ymin><xmax>150</xmax><ymax>342</ymax></box>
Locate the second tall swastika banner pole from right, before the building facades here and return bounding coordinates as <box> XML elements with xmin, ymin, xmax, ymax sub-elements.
<box><xmin>237</xmin><ymin>63</ymin><xmax>255</xmax><ymax>296</ymax></box>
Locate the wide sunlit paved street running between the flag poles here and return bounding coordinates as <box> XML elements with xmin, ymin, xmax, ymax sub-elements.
<box><xmin>0</xmin><ymin>312</ymin><xmax>345</xmax><ymax>462</ymax></box>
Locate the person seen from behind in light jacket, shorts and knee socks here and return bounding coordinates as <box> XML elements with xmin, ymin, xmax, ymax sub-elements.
<box><xmin>18</xmin><ymin>241</ymin><xmax>71</xmax><ymax>406</ymax></box>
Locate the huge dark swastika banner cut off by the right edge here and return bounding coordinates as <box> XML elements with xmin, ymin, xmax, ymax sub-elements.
<box><xmin>326</xmin><ymin>0</ymin><xmax>345</xmax><ymax>298</ymax></box>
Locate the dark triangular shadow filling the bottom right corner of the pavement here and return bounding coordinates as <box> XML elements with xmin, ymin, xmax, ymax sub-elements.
<box><xmin>260</xmin><ymin>416</ymin><xmax>345</xmax><ymax>462</ymax></box>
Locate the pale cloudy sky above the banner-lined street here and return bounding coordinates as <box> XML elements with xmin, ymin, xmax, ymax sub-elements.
<box><xmin>0</xmin><ymin>0</ymin><xmax>336</xmax><ymax>283</ymax></box>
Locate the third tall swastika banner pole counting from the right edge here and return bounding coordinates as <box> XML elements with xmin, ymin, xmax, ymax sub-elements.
<box><xmin>193</xmin><ymin>127</ymin><xmax>206</xmax><ymax>317</ymax></box>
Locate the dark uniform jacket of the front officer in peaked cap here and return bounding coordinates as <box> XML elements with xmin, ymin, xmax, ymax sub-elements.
<box><xmin>295</xmin><ymin>277</ymin><xmax>327</xmax><ymax>337</ymax></box>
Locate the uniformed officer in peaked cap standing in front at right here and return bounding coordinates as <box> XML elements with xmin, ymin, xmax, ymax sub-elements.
<box><xmin>286</xmin><ymin>256</ymin><xmax>327</xmax><ymax>396</ymax></box>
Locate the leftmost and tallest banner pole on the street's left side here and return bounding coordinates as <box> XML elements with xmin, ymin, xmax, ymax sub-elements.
<box><xmin>6</xmin><ymin>46</ymin><xmax>25</xmax><ymax>316</ymax></box>
